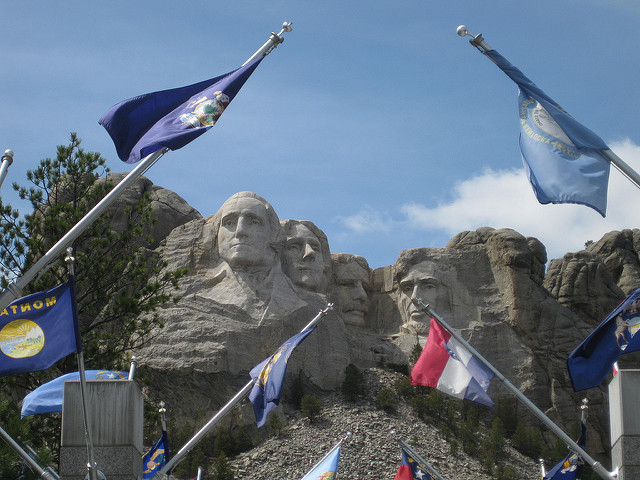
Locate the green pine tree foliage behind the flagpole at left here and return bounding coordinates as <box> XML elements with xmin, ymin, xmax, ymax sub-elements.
<box><xmin>0</xmin><ymin>133</ymin><xmax>186</xmax><ymax>478</ymax></box>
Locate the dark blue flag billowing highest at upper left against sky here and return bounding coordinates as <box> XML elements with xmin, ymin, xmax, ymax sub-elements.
<box><xmin>98</xmin><ymin>56</ymin><xmax>264</xmax><ymax>163</ymax></box>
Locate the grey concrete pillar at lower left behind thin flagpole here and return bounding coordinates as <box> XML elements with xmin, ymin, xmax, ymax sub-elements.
<box><xmin>59</xmin><ymin>380</ymin><xmax>144</xmax><ymax>480</ymax></box>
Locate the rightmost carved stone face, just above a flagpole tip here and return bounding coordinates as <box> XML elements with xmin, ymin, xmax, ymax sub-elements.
<box><xmin>398</xmin><ymin>261</ymin><xmax>438</xmax><ymax>333</ymax></box>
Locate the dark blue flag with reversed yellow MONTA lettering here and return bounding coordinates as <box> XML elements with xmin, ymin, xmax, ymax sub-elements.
<box><xmin>0</xmin><ymin>280</ymin><xmax>81</xmax><ymax>376</ymax></box>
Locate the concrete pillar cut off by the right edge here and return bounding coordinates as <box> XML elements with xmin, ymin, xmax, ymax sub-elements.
<box><xmin>609</xmin><ymin>370</ymin><xmax>640</xmax><ymax>480</ymax></box>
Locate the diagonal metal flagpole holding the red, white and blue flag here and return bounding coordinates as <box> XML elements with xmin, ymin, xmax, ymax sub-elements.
<box><xmin>414</xmin><ymin>298</ymin><xmax>614</xmax><ymax>480</ymax></box>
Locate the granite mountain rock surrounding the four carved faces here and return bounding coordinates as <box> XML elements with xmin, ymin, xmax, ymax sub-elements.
<box><xmin>104</xmin><ymin>178</ymin><xmax>640</xmax><ymax>464</ymax></box>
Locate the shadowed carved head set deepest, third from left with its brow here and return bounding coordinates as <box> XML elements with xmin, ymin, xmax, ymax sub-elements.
<box><xmin>331</xmin><ymin>253</ymin><xmax>371</xmax><ymax>327</ymax></box>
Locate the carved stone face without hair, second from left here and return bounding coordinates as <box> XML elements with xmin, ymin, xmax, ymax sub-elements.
<box><xmin>283</xmin><ymin>223</ymin><xmax>324</xmax><ymax>292</ymax></box>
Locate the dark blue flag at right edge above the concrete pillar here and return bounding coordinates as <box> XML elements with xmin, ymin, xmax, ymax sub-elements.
<box><xmin>567</xmin><ymin>288</ymin><xmax>640</xmax><ymax>392</ymax></box>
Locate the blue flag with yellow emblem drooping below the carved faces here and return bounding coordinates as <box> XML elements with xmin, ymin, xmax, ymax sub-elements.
<box><xmin>249</xmin><ymin>327</ymin><xmax>315</xmax><ymax>427</ymax></box>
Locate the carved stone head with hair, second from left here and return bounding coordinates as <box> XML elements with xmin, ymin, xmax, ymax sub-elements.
<box><xmin>280</xmin><ymin>220</ymin><xmax>331</xmax><ymax>293</ymax></box>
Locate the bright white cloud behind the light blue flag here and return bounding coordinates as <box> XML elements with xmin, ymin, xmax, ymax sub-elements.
<box><xmin>401</xmin><ymin>140</ymin><xmax>640</xmax><ymax>259</ymax></box>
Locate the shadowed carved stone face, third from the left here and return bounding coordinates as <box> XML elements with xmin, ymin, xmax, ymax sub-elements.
<box><xmin>333</xmin><ymin>260</ymin><xmax>369</xmax><ymax>327</ymax></box>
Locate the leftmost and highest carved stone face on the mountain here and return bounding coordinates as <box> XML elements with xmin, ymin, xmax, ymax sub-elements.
<box><xmin>218</xmin><ymin>197</ymin><xmax>274</xmax><ymax>267</ymax></box>
